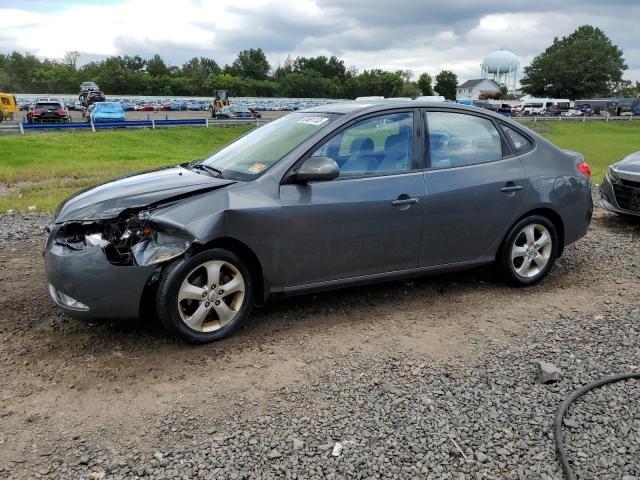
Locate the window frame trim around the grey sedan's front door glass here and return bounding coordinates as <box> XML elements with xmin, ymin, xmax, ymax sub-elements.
<box><xmin>280</xmin><ymin>107</ymin><xmax>424</xmax><ymax>184</ymax></box>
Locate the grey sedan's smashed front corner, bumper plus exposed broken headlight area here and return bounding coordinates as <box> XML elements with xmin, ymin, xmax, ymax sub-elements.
<box><xmin>44</xmin><ymin>211</ymin><xmax>195</xmax><ymax>319</ymax></box>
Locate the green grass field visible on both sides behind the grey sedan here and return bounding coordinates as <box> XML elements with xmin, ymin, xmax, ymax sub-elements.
<box><xmin>0</xmin><ymin>122</ymin><xmax>640</xmax><ymax>212</ymax></box>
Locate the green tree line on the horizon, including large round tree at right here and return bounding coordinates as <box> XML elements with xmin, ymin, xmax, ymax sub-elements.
<box><xmin>0</xmin><ymin>25</ymin><xmax>640</xmax><ymax>100</ymax></box>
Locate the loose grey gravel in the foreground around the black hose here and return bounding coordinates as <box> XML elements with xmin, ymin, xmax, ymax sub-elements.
<box><xmin>33</xmin><ymin>310</ymin><xmax>640</xmax><ymax>479</ymax></box>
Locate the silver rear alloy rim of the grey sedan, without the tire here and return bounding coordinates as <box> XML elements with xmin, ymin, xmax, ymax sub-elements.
<box><xmin>511</xmin><ymin>223</ymin><xmax>553</xmax><ymax>278</ymax></box>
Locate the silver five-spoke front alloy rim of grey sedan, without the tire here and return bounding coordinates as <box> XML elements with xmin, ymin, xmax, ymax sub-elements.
<box><xmin>178</xmin><ymin>260</ymin><xmax>245</xmax><ymax>332</ymax></box>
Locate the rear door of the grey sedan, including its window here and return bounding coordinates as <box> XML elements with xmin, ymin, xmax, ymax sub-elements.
<box><xmin>420</xmin><ymin>109</ymin><xmax>529</xmax><ymax>267</ymax></box>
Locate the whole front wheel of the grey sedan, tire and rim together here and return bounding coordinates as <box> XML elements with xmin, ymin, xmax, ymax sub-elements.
<box><xmin>156</xmin><ymin>248</ymin><xmax>253</xmax><ymax>343</ymax></box>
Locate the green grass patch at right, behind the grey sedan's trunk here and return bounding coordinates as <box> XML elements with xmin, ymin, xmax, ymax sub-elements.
<box><xmin>523</xmin><ymin>120</ymin><xmax>640</xmax><ymax>183</ymax></box>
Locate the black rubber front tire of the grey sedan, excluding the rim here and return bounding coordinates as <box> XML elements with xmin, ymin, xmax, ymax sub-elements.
<box><xmin>156</xmin><ymin>248</ymin><xmax>253</xmax><ymax>344</ymax></box>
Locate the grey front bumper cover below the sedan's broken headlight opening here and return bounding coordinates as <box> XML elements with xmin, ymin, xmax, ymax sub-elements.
<box><xmin>44</xmin><ymin>242</ymin><xmax>158</xmax><ymax>319</ymax></box>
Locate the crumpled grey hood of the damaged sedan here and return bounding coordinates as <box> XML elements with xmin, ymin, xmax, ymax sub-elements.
<box><xmin>55</xmin><ymin>166</ymin><xmax>235</xmax><ymax>223</ymax></box>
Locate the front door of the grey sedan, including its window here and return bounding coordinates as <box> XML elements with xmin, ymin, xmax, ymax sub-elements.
<box><xmin>280</xmin><ymin>110</ymin><xmax>424</xmax><ymax>288</ymax></box>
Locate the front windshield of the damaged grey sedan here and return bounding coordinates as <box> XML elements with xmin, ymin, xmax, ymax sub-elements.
<box><xmin>203</xmin><ymin>113</ymin><xmax>337</xmax><ymax>181</ymax></box>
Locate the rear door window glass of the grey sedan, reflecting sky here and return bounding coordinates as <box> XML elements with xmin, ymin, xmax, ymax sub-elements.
<box><xmin>426</xmin><ymin>112</ymin><xmax>503</xmax><ymax>168</ymax></box>
